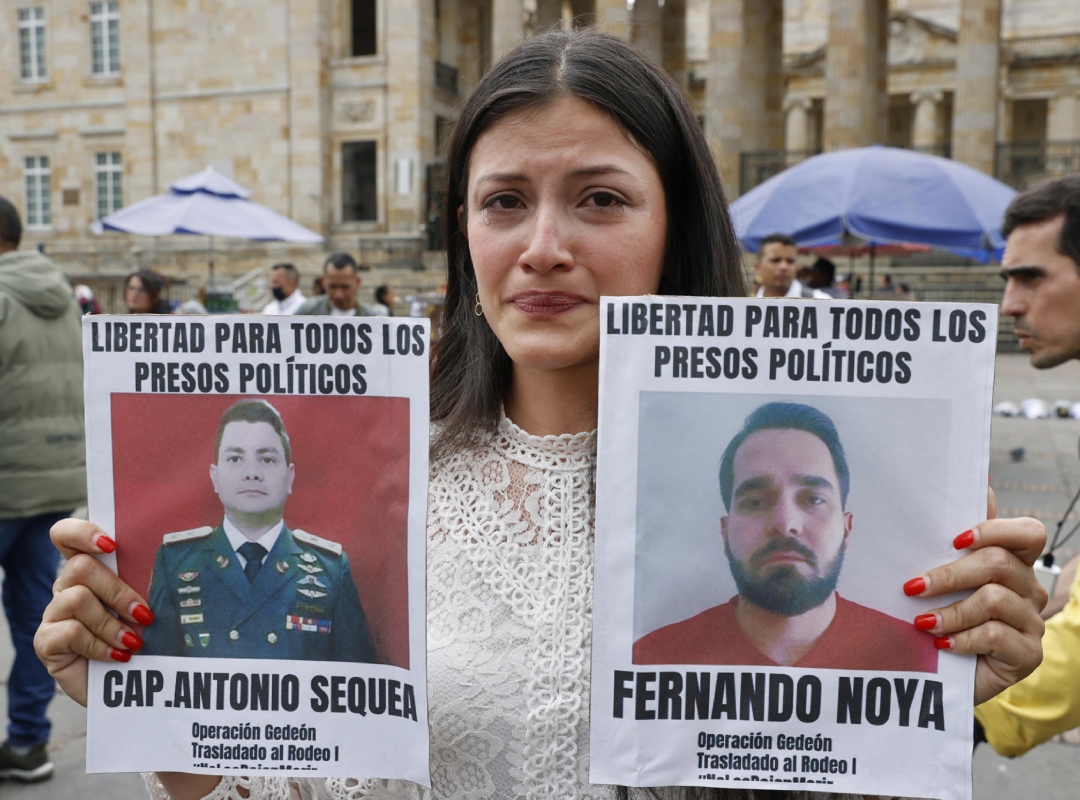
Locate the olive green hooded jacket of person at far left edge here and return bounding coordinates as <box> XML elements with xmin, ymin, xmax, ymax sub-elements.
<box><xmin>0</xmin><ymin>250</ymin><xmax>86</xmax><ymax>519</ymax></box>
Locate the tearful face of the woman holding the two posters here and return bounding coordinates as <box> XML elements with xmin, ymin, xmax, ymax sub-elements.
<box><xmin>461</xmin><ymin>97</ymin><xmax>667</xmax><ymax>369</ymax></box>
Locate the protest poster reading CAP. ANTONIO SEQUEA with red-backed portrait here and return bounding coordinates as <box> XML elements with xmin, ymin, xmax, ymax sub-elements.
<box><xmin>83</xmin><ymin>316</ymin><xmax>430</xmax><ymax>785</ymax></box>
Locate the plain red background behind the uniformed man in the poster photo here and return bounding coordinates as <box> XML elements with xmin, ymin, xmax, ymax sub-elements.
<box><xmin>112</xmin><ymin>394</ymin><xmax>410</xmax><ymax>669</ymax></box>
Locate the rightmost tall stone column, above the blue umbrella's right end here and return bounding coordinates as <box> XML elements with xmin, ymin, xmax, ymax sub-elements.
<box><xmin>953</xmin><ymin>0</ymin><xmax>1001</xmax><ymax>175</ymax></box>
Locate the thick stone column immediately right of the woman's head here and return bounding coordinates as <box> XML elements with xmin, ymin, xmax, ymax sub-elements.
<box><xmin>705</xmin><ymin>0</ymin><xmax>784</xmax><ymax>192</ymax></box>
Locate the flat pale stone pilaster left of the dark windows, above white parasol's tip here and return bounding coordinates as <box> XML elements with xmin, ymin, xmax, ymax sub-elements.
<box><xmin>287</xmin><ymin>0</ymin><xmax>334</xmax><ymax>232</ymax></box>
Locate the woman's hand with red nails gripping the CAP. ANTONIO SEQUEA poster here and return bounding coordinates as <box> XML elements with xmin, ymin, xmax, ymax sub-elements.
<box><xmin>33</xmin><ymin>519</ymin><xmax>153</xmax><ymax>705</ymax></box>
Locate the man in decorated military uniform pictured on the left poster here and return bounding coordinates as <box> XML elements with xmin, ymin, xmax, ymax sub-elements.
<box><xmin>143</xmin><ymin>399</ymin><xmax>376</xmax><ymax>663</ymax></box>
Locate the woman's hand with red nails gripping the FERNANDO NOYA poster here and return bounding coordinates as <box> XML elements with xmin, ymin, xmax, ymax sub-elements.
<box><xmin>904</xmin><ymin>490</ymin><xmax>1047</xmax><ymax>705</ymax></box>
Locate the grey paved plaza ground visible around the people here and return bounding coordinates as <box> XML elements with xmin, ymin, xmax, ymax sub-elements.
<box><xmin>0</xmin><ymin>355</ymin><xmax>1080</xmax><ymax>800</ymax></box>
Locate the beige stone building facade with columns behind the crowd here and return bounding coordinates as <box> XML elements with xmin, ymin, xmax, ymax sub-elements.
<box><xmin>6</xmin><ymin>0</ymin><xmax>1080</xmax><ymax>294</ymax></box>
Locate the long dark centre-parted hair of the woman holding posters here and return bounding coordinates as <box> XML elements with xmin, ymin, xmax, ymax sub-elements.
<box><xmin>431</xmin><ymin>29</ymin><xmax>746</xmax><ymax>460</ymax></box>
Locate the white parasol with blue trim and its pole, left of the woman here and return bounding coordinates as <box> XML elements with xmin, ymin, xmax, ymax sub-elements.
<box><xmin>90</xmin><ymin>166</ymin><xmax>323</xmax><ymax>285</ymax></box>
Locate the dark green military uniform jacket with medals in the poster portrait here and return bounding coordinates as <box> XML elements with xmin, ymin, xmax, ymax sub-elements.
<box><xmin>141</xmin><ymin>525</ymin><xmax>376</xmax><ymax>663</ymax></box>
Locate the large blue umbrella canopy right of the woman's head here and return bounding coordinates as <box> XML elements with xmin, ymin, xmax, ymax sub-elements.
<box><xmin>731</xmin><ymin>145</ymin><xmax>1016</xmax><ymax>263</ymax></box>
